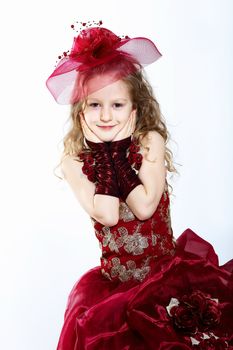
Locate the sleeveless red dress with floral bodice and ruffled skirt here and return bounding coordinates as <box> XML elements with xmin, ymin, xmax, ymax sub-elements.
<box><xmin>57</xmin><ymin>147</ymin><xmax>233</xmax><ymax>350</ymax></box>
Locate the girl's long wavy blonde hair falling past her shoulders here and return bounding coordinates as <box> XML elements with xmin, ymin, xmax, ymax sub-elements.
<box><xmin>54</xmin><ymin>59</ymin><xmax>179</xmax><ymax>194</ymax></box>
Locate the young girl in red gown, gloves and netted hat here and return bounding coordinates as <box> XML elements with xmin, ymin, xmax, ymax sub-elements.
<box><xmin>46</xmin><ymin>23</ymin><xmax>233</xmax><ymax>350</ymax></box>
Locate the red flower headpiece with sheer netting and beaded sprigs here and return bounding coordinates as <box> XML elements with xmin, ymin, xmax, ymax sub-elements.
<box><xmin>46</xmin><ymin>21</ymin><xmax>162</xmax><ymax>104</ymax></box>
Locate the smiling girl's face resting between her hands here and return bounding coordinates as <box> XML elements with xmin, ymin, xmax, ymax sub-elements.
<box><xmin>83</xmin><ymin>76</ymin><xmax>133</xmax><ymax>141</ymax></box>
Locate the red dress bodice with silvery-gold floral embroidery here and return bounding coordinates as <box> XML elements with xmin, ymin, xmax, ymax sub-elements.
<box><xmin>91</xmin><ymin>181</ymin><xmax>175</xmax><ymax>282</ymax></box>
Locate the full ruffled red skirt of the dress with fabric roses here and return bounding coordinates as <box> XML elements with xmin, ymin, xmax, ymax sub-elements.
<box><xmin>57</xmin><ymin>228</ymin><xmax>233</xmax><ymax>350</ymax></box>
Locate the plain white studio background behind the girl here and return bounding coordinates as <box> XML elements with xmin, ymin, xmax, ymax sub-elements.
<box><xmin>0</xmin><ymin>0</ymin><xmax>233</xmax><ymax>350</ymax></box>
